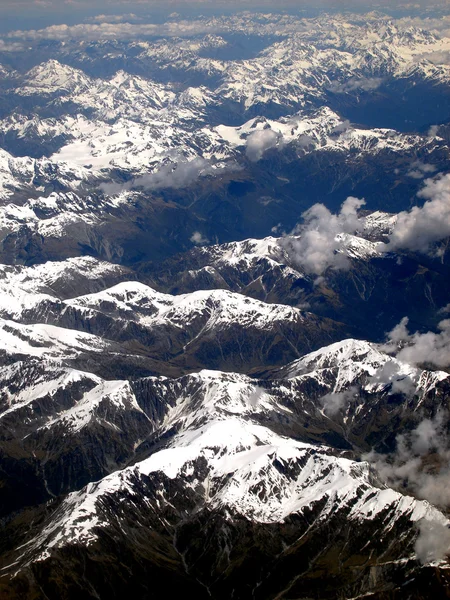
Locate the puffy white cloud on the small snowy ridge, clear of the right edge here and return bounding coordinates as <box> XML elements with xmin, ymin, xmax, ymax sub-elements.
<box><xmin>282</xmin><ymin>197</ymin><xmax>365</xmax><ymax>275</ymax></box>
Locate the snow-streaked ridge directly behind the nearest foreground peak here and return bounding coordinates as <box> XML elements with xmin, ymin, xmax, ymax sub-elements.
<box><xmin>0</xmin><ymin>338</ymin><xmax>449</xmax><ymax>435</ymax></box>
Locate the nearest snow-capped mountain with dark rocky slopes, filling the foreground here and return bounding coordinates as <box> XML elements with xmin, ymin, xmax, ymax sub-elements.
<box><xmin>1</xmin><ymin>412</ymin><xmax>445</xmax><ymax>598</ymax></box>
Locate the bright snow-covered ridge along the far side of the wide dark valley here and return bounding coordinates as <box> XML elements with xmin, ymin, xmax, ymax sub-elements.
<box><xmin>0</xmin><ymin>103</ymin><xmax>436</xmax><ymax>179</ymax></box>
